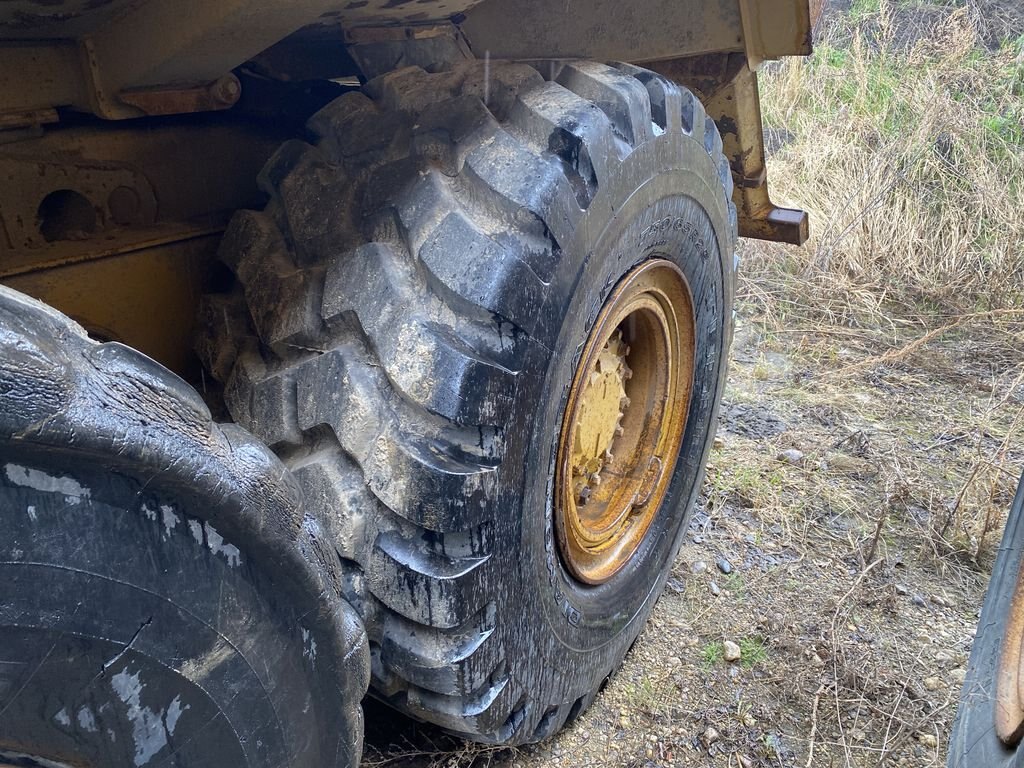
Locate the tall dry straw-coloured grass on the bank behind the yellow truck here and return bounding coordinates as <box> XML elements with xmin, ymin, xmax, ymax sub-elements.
<box><xmin>746</xmin><ymin>0</ymin><xmax>1024</xmax><ymax>326</ymax></box>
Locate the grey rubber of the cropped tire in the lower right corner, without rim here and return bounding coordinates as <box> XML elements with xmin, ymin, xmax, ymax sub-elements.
<box><xmin>949</xmin><ymin>477</ymin><xmax>1024</xmax><ymax>768</ymax></box>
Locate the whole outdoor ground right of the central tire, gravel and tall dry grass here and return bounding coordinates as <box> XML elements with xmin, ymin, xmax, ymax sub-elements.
<box><xmin>367</xmin><ymin>0</ymin><xmax>1024</xmax><ymax>768</ymax></box>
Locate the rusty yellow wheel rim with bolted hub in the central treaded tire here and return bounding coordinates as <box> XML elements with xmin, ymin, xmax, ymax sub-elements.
<box><xmin>555</xmin><ymin>259</ymin><xmax>695</xmax><ymax>585</ymax></box>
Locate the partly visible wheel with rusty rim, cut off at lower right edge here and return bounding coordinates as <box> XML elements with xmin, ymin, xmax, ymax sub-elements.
<box><xmin>949</xmin><ymin>477</ymin><xmax>1024</xmax><ymax>768</ymax></box>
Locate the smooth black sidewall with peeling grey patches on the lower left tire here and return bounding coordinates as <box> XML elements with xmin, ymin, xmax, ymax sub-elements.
<box><xmin>0</xmin><ymin>450</ymin><xmax>324</xmax><ymax>766</ymax></box>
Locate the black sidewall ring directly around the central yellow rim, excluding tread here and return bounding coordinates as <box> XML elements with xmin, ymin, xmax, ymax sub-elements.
<box><xmin>519</xmin><ymin>134</ymin><xmax>732</xmax><ymax>655</ymax></box>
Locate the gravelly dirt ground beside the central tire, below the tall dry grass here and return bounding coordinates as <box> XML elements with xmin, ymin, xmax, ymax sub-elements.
<box><xmin>365</xmin><ymin>274</ymin><xmax>1024</xmax><ymax>768</ymax></box>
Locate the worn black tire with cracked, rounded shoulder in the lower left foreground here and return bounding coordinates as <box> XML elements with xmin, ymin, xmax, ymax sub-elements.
<box><xmin>0</xmin><ymin>288</ymin><xmax>369</xmax><ymax>768</ymax></box>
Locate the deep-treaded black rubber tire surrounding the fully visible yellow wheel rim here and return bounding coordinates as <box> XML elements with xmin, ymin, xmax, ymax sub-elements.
<box><xmin>199</xmin><ymin>61</ymin><xmax>736</xmax><ymax>742</ymax></box>
